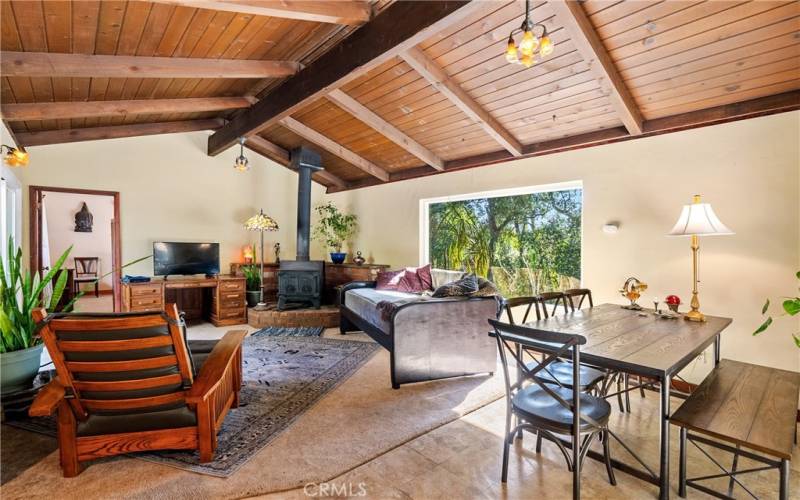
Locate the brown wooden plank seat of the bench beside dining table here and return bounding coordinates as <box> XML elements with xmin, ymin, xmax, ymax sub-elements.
<box><xmin>670</xmin><ymin>359</ymin><xmax>800</xmax><ymax>460</ymax></box>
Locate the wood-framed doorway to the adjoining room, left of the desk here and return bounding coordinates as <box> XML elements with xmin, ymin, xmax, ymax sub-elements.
<box><xmin>28</xmin><ymin>186</ymin><xmax>122</xmax><ymax>312</ymax></box>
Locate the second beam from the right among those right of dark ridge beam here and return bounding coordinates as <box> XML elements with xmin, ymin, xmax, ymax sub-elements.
<box><xmin>401</xmin><ymin>47</ymin><xmax>523</xmax><ymax>156</ymax></box>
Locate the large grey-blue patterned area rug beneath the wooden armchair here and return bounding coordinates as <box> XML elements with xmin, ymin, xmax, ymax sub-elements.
<box><xmin>8</xmin><ymin>336</ymin><xmax>380</xmax><ymax>477</ymax></box>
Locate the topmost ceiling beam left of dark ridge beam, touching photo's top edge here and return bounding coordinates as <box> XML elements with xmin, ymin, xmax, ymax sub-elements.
<box><xmin>150</xmin><ymin>0</ymin><xmax>372</xmax><ymax>25</ymax></box>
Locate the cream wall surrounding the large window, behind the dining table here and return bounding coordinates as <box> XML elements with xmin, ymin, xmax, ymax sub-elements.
<box><xmin>329</xmin><ymin>112</ymin><xmax>800</xmax><ymax>379</ymax></box>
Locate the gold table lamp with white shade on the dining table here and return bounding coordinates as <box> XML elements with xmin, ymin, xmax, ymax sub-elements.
<box><xmin>669</xmin><ymin>194</ymin><xmax>734</xmax><ymax>321</ymax></box>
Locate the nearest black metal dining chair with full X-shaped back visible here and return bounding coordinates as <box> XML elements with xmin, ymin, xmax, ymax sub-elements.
<box><xmin>489</xmin><ymin>319</ymin><xmax>617</xmax><ymax>499</ymax></box>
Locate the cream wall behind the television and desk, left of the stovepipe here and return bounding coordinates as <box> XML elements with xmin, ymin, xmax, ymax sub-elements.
<box><xmin>16</xmin><ymin>132</ymin><xmax>323</xmax><ymax>275</ymax></box>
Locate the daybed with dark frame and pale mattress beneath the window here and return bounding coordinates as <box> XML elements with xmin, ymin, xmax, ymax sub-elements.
<box><xmin>339</xmin><ymin>270</ymin><xmax>499</xmax><ymax>389</ymax></box>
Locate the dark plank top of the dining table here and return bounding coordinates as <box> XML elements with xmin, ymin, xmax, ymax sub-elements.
<box><xmin>525</xmin><ymin>304</ymin><xmax>732</xmax><ymax>377</ymax></box>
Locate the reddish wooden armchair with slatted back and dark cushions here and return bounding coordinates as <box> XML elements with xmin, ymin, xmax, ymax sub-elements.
<box><xmin>29</xmin><ymin>304</ymin><xmax>247</xmax><ymax>477</ymax></box>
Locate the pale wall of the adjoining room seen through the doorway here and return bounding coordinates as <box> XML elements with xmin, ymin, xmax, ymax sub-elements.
<box><xmin>44</xmin><ymin>191</ymin><xmax>114</xmax><ymax>290</ymax></box>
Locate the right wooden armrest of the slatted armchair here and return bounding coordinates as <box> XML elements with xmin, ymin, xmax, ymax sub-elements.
<box><xmin>186</xmin><ymin>330</ymin><xmax>247</xmax><ymax>404</ymax></box>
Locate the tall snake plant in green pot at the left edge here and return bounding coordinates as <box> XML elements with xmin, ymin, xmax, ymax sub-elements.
<box><xmin>0</xmin><ymin>238</ymin><xmax>74</xmax><ymax>394</ymax></box>
